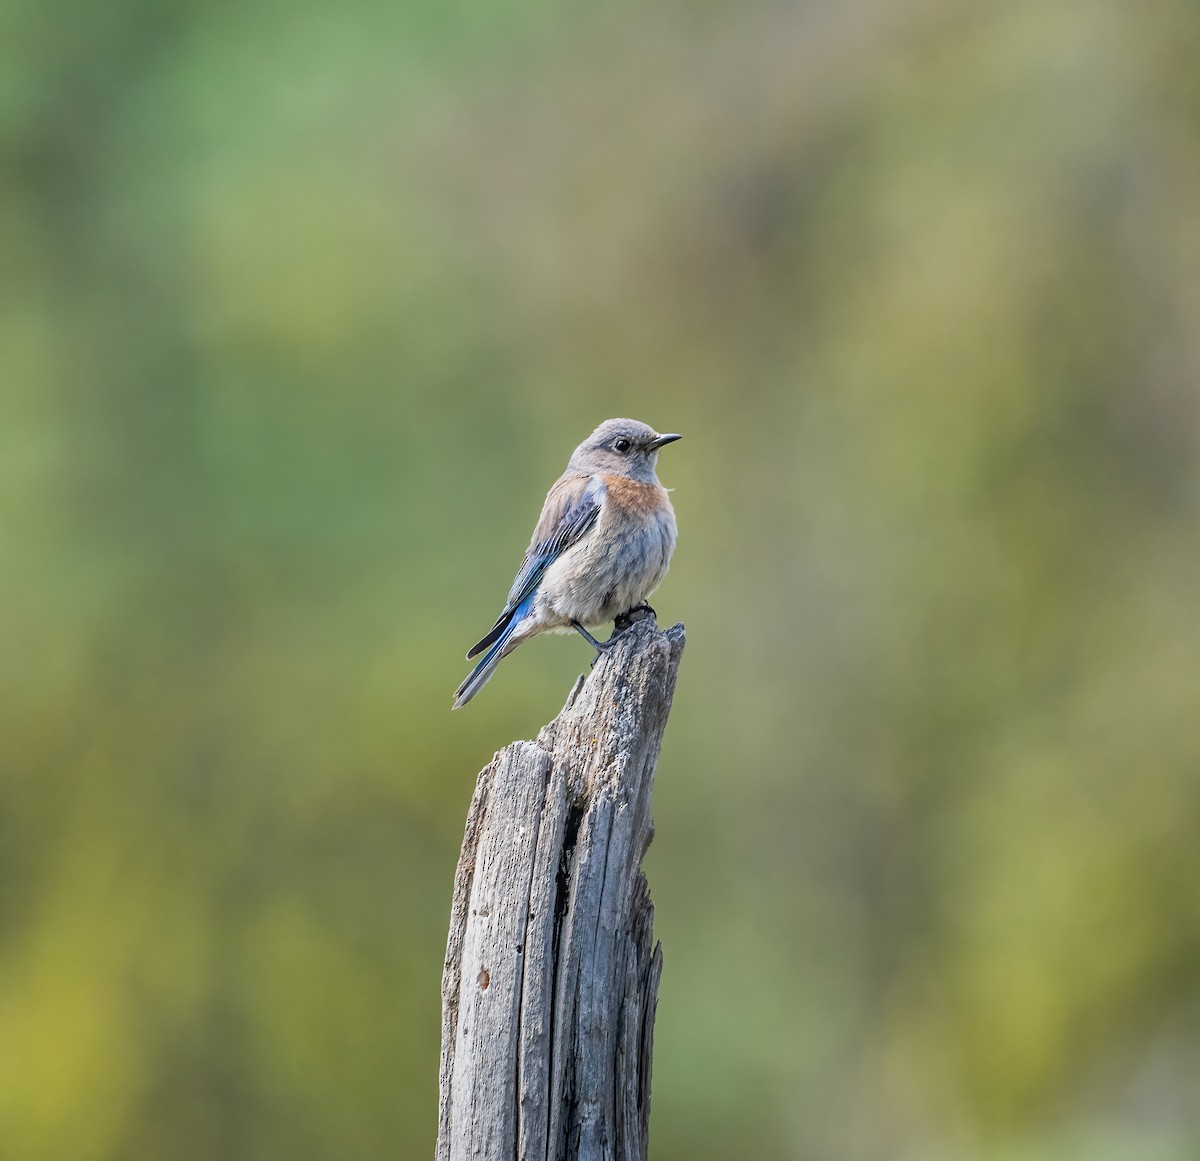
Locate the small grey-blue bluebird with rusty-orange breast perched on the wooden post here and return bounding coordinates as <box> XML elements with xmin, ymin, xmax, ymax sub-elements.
<box><xmin>454</xmin><ymin>420</ymin><xmax>679</xmax><ymax>709</ymax></box>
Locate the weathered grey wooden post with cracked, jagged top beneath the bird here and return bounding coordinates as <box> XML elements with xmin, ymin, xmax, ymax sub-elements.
<box><xmin>437</xmin><ymin>613</ymin><xmax>684</xmax><ymax>1161</ymax></box>
